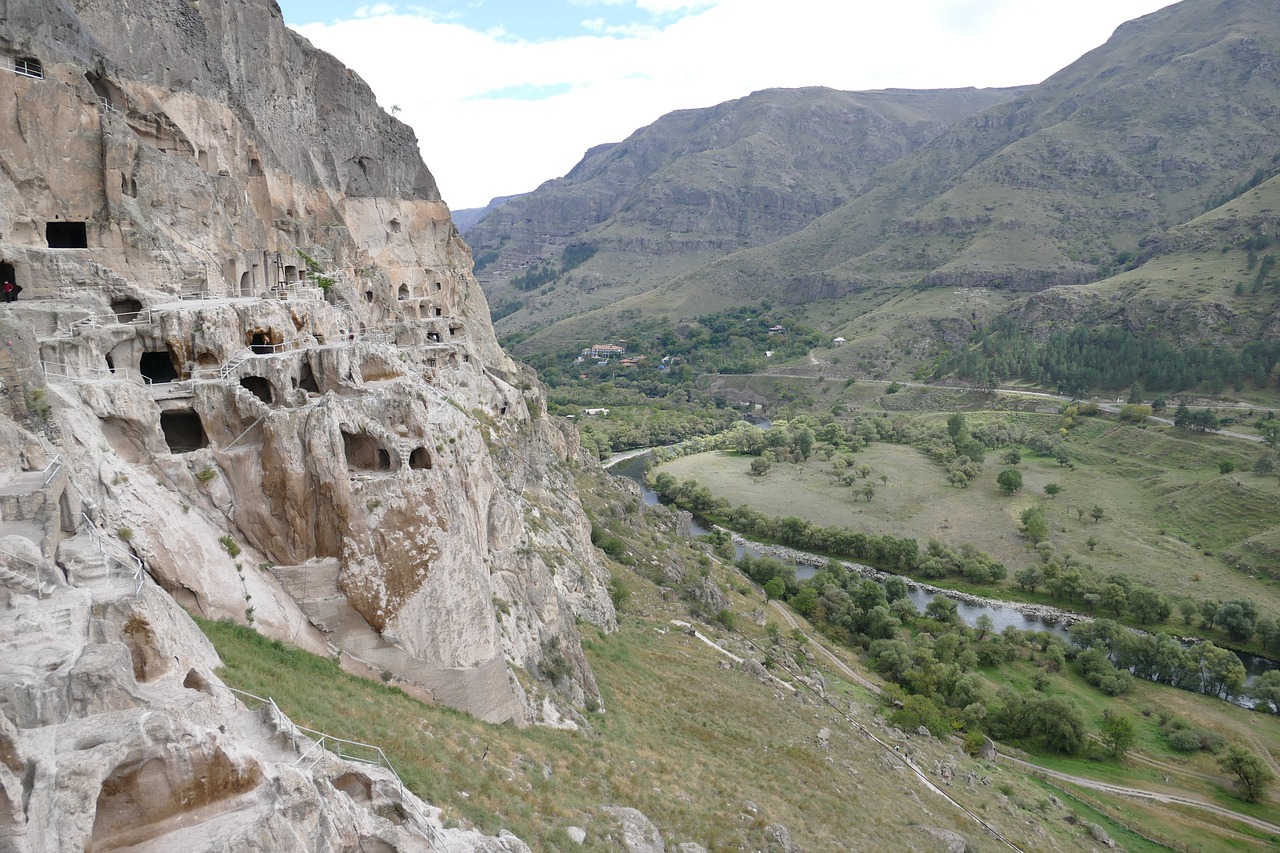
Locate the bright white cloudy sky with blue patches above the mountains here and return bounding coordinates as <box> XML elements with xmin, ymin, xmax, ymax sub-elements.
<box><xmin>290</xmin><ymin>0</ymin><xmax>1169</xmax><ymax>210</ymax></box>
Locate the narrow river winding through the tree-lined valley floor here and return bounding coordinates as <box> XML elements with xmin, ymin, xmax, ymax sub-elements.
<box><xmin>605</xmin><ymin>451</ymin><xmax>1280</xmax><ymax>707</ymax></box>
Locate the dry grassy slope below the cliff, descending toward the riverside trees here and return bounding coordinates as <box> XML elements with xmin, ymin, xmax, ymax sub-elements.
<box><xmin>194</xmin><ymin>461</ymin><xmax>1280</xmax><ymax>850</ymax></box>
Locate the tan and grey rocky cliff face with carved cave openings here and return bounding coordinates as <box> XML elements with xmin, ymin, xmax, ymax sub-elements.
<box><xmin>0</xmin><ymin>0</ymin><xmax>614</xmax><ymax>849</ymax></box>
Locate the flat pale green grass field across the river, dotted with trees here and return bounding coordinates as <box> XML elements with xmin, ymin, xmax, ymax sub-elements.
<box><xmin>659</xmin><ymin>412</ymin><xmax>1280</xmax><ymax>613</ymax></box>
